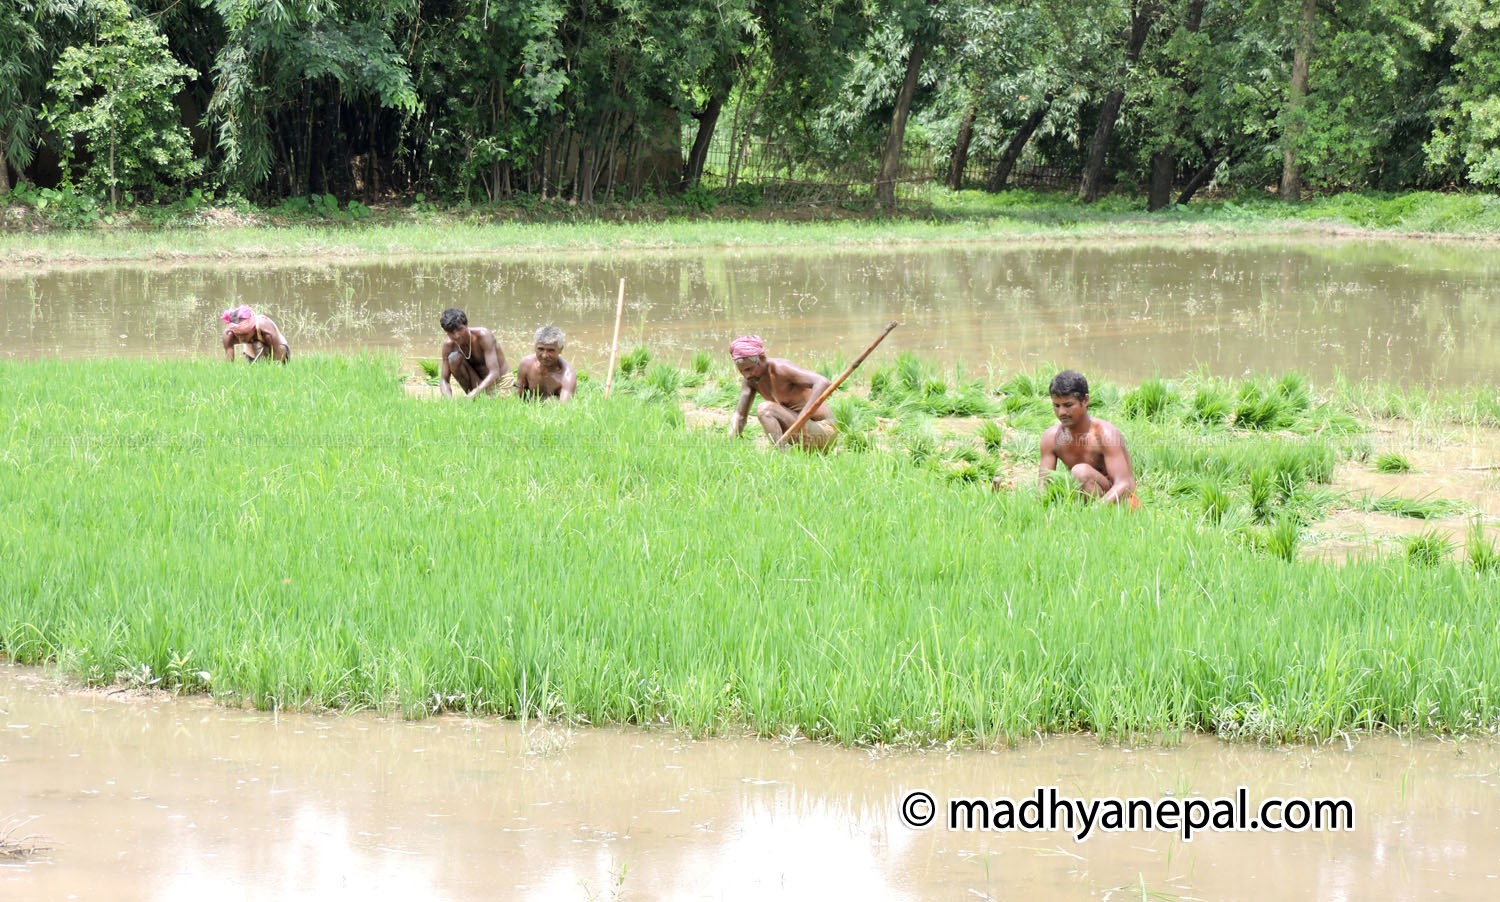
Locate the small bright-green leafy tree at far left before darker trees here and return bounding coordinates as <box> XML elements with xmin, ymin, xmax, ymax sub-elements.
<box><xmin>45</xmin><ymin>0</ymin><xmax>203</xmax><ymax>207</ymax></box>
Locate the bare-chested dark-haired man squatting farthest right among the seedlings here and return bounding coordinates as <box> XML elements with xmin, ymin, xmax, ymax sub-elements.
<box><xmin>1041</xmin><ymin>369</ymin><xmax>1140</xmax><ymax>507</ymax></box>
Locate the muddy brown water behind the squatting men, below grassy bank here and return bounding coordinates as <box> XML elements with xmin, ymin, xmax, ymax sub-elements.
<box><xmin>0</xmin><ymin>239</ymin><xmax>1500</xmax><ymax>386</ymax></box>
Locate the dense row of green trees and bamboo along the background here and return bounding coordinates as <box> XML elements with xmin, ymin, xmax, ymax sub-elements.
<box><xmin>0</xmin><ymin>0</ymin><xmax>1500</xmax><ymax>209</ymax></box>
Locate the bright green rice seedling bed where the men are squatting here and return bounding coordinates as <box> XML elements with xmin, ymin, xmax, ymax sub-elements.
<box><xmin>0</xmin><ymin>354</ymin><xmax>1500</xmax><ymax>743</ymax></box>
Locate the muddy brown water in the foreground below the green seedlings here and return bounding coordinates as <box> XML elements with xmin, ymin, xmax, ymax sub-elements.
<box><xmin>0</xmin><ymin>666</ymin><xmax>1500</xmax><ymax>900</ymax></box>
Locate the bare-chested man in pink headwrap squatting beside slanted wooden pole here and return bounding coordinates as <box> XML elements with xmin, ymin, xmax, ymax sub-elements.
<box><xmin>729</xmin><ymin>335</ymin><xmax>839</xmax><ymax>449</ymax></box>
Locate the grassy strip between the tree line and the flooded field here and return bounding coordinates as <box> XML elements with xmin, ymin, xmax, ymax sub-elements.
<box><xmin>0</xmin><ymin>189</ymin><xmax>1500</xmax><ymax>266</ymax></box>
